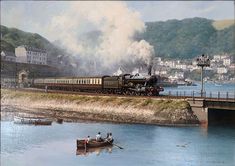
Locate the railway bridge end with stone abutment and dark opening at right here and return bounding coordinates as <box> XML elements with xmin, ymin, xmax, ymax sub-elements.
<box><xmin>187</xmin><ymin>98</ymin><xmax>235</xmax><ymax>125</ymax></box>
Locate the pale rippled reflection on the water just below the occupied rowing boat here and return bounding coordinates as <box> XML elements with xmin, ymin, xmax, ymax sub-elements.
<box><xmin>76</xmin><ymin>145</ymin><xmax>113</xmax><ymax>156</ymax></box>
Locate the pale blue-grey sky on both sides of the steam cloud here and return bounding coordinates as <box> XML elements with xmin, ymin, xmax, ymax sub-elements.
<box><xmin>1</xmin><ymin>1</ymin><xmax>234</xmax><ymax>41</ymax></box>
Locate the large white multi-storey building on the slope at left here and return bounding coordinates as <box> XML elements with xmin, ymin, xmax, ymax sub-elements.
<box><xmin>15</xmin><ymin>46</ymin><xmax>47</xmax><ymax>65</ymax></box>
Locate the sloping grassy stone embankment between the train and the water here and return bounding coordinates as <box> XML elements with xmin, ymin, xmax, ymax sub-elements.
<box><xmin>1</xmin><ymin>89</ymin><xmax>199</xmax><ymax>125</ymax></box>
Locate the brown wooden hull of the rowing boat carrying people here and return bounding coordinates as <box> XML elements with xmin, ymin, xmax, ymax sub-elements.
<box><xmin>77</xmin><ymin>139</ymin><xmax>113</xmax><ymax>149</ymax></box>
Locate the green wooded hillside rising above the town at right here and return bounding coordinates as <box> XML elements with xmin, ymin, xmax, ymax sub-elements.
<box><xmin>139</xmin><ymin>18</ymin><xmax>235</xmax><ymax>59</ymax></box>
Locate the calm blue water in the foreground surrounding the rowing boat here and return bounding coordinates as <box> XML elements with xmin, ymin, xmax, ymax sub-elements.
<box><xmin>1</xmin><ymin>121</ymin><xmax>235</xmax><ymax>166</ymax></box>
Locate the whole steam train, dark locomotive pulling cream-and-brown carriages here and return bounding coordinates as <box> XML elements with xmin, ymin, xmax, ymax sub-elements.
<box><xmin>33</xmin><ymin>74</ymin><xmax>164</xmax><ymax>96</ymax></box>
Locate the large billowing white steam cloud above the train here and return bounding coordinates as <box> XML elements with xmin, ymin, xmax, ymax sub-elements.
<box><xmin>49</xmin><ymin>1</ymin><xmax>154</xmax><ymax>74</ymax></box>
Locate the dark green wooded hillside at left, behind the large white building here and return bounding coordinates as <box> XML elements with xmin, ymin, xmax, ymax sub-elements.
<box><xmin>1</xmin><ymin>25</ymin><xmax>79</xmax><ymax>75</ymax></box>
